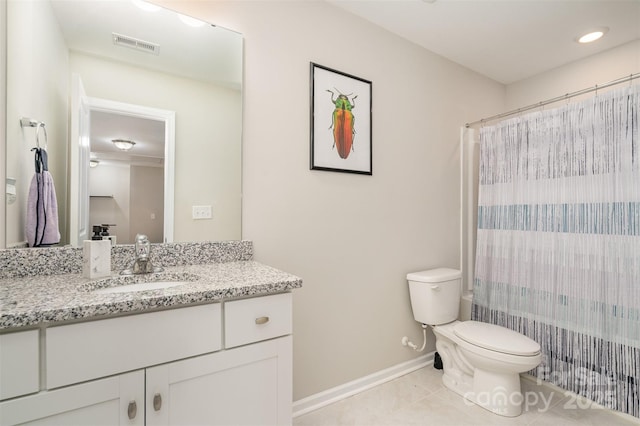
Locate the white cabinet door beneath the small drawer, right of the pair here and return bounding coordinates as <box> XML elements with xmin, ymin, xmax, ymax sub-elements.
<box><xmin>147</xmin><ymin>336</ymin><xmax>292</xmax><ymax>425</ymax></box>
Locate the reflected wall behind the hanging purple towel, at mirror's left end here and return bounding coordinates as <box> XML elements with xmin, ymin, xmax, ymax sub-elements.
<box><xmin>3</xmin><ymin>1</ymin><xmax>69</xmax><ymax>247</ymax></box>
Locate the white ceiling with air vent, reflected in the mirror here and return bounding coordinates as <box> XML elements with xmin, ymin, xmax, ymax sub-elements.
<box><xmin>51</xmin><ymin>0</ymin><xmax>242</xmax><ymax>89</ymax></box>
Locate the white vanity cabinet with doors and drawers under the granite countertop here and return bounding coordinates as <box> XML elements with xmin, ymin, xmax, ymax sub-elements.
<box><xmin>0</xmin><ymin>293</ymin><xmax>292</xmax><ymax>425</ymax></box>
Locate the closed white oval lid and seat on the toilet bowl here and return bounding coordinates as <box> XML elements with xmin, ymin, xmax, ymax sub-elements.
<box><xmin>453</xmin><ymin>321</ymin><xmax>540</xmax><ymax>356</ymax></box>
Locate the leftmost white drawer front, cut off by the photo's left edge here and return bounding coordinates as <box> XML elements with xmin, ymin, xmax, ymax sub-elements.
<box><xmin>0</xmin><ymin>330</ymin><xmax>40</xmax><ymax>399</ymax></box>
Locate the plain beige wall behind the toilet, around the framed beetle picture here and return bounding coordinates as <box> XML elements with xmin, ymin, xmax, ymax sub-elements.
<box><xmin>156</xmin><ymin>1</ymin><xmax>504</xmax><ymax>400</ymax></box>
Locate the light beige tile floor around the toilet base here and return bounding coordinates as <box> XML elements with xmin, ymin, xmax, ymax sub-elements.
<box><xmin>293</xmin><ymin>365</ymin><xmax>640</xmax><ymax>426</ymax></box>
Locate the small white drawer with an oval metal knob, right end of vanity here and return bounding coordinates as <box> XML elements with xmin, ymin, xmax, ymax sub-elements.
<box><xmin>224</xmin><ymin>293</ymin><xmax>291</xmax><ymax>348</ymax></box>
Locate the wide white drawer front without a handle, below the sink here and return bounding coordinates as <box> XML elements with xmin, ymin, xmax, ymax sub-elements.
<box><xmin>46</xmin><ymin>303</ymin><xmax>222</xmax><ymax>389</ymax></box>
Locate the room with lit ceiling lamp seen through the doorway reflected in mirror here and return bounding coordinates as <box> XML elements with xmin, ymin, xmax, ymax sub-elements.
<box><xmin>88</xmin><ymin>110</ymin><xmax>165</xmax><ymax>244</ymax></box>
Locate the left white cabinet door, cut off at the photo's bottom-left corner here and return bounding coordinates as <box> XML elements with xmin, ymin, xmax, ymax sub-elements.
<box><xmin>0</xmin><ymin>371</ymin><xmax>144</xmax><ymax>426</ymax></box>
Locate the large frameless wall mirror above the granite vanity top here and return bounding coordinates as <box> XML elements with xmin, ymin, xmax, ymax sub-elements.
<box><xmin>5</xmin><ymin>0</ymin><xmax>242</xmax><ymax>248</ymax></box>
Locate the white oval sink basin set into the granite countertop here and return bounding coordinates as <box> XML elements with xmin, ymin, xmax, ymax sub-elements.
<box><xmin>83</xmin><ymin>273</ymin><xmax>200</xmax><ymax>294</ymax></box>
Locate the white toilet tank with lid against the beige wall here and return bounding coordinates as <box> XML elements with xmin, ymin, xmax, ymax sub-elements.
<box><xmin>407</xmin><ymin>268</ymin><xmax>462</xmax><ymax>325</ymax></box>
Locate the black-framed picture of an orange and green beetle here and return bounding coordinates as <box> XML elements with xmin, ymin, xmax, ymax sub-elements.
<box><xmin>310</xmin><ymin>62</ymin><xmax>373</xmax><ymax>175</ymax></box>
